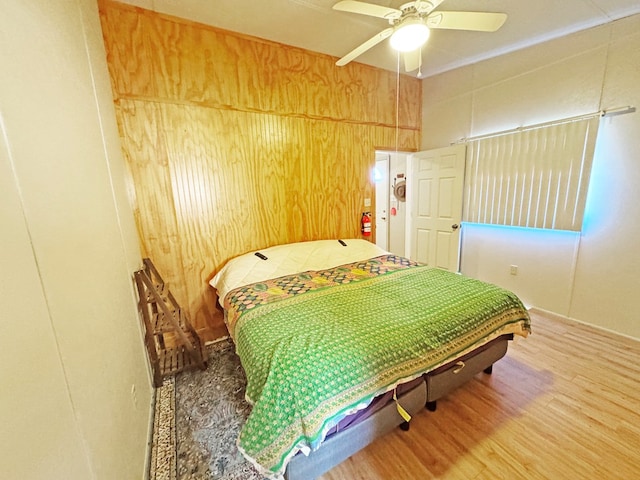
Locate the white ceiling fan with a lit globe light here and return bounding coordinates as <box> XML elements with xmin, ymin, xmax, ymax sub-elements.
<box><xmin>333</xmin><ymin>0</ymin><xmax>507</xmax><ymax>72</ymax></box>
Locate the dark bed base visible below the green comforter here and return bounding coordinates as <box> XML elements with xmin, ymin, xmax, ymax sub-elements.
<box><xmin>284</xmin><ymin>335</ymin><xmax>513</xmax><ymax>480</ymax></box>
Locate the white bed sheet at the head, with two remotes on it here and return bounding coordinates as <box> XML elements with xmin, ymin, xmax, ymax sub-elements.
<box><xmin>209</xmin><ymin>238</ymin><xmax>388</xmax><ymax>306</ymax></box>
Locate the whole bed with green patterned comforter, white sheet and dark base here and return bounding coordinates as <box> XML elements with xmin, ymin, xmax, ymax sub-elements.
<box><xmin>210</xmin><ymin>239</ymin><xmax>531</xmax><ymax>480</ymax></box>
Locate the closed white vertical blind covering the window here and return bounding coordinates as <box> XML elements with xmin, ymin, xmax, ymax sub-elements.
<box><xmin>464</xmin><ymin>117</ymin><xmax>600</xmax><ymax>231</ymax></box>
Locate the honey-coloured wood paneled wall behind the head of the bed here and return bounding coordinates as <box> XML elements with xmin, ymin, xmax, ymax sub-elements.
<box><xmin>100</xmin><ymin>1</ymin><xmax>422</xmax><ymax>337</ymax></box>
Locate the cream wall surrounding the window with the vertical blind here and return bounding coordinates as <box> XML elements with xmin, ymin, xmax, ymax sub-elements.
<box><xmin>422</xmin><ymin>15</ymin><xmax>640</xmax><ymax>338</ymax></box>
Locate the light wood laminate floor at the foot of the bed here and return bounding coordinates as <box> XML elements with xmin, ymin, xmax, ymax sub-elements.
<box><xmin>320</xmin><ymin>313</ymin><xmax>640</xmax><ymax>480</ymax></box>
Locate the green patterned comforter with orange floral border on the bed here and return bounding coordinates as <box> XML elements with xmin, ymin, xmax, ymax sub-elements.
<box><xmin>225</xmin><ymin>255</ymin><xmax>530</xmax><ymax>478</ymax></box>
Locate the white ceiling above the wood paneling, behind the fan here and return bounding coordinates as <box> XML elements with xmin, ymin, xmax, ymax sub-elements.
<box><xmin>116</xmin><ymin>0</ymin><xmax>640</xmax><ymax>76</ymax></box>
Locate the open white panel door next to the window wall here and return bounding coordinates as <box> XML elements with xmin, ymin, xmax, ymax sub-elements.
<box><xmin>407</xmin><ymin>145</ymin><xmax>466</xmax><ymax>272</ymax></box>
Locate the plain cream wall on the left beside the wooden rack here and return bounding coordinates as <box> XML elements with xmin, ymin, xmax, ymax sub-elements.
<box><xmin>0</xmin><ymin>0</ymin><xmax>153</xmax><ymax>480</ymax></box>
